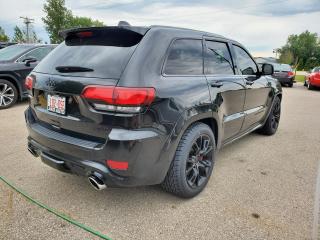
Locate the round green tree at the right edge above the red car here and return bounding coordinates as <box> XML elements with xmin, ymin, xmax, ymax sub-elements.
<box><xmin>279</xmin><ymin>31</ymin><xmax>320</xmax><ymax>69</ymax></box>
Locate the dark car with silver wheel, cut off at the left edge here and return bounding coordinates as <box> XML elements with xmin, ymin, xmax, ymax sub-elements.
<box><xmin>0</xmin><ymin>44</ymin><xmax>55</xmax><ymax>110</ymax></box>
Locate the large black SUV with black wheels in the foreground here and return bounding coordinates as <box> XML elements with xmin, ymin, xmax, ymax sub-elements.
<box><xmin>25</xmin><ymin>26</ymin><xmax>282</xmax><ymax>197</ymax></box>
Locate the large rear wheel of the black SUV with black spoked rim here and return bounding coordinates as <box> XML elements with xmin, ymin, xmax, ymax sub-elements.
<box><xmin>161</xmin><ymin>123</ymin><xmax>216</xmax><ymax>198</ymax></box>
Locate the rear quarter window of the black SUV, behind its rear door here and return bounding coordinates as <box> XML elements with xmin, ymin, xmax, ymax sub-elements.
<box><xmin>164</xmin><ymin>39</ymin><xmax>203</xmax><ymax>75</ymax></box>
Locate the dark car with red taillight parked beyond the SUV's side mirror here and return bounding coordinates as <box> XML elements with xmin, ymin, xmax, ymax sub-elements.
<box><xmin>258</xmin><ymin>63</ymin><xmax>295</xmax><ymax>87</ymax></box>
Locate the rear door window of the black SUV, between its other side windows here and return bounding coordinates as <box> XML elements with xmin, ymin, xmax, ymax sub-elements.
<box><xmin>204</xmin><ymin>41</ymin><xmax>234</xmax><ymax>75</ymax></box>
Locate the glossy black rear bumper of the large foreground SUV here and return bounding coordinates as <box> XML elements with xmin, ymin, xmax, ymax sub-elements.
<box><xmin>25</xmin><ymin>108</ymin><xmax>169</xmax><ymax>187</ymax></box>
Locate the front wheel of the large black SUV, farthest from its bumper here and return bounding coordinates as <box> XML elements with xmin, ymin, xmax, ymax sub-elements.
<box><xmin>258</xmin><ymin>97</ymin><xmax>281</xmax><ymax>136</ymax></box>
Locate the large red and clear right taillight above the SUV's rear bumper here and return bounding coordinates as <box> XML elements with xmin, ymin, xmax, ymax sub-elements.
<box><xmin>82</xmin><ymin>86</ymin><xmax>155</xmax><ymax>113</ymax></box>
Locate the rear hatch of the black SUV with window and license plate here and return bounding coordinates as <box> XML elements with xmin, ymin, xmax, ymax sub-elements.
<box><xmin>29</xmin><ymin>27</ymin><xmax>148</xmax><ymax>141</ymax></box>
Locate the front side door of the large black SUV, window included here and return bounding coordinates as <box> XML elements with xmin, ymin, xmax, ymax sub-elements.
<box><xmin>233</xmin><ymin>45</ymin><xmax>271</xmax><ymax>131</ymax></box>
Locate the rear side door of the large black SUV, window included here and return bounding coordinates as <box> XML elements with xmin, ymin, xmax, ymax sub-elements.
<box><xmin>204</xmin><ymin>38</ymin><xmax>245</xmax><ymax>140</ymax></box>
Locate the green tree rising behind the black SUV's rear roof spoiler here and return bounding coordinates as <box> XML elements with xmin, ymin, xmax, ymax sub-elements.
<box><xmin>42</xmin><ymin>0</ymin><xmax>103</xmax><ymax>43</ymax></box>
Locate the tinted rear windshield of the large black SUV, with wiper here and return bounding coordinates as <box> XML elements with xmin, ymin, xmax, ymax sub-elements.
<box><xmin>34</xmin><ymin>29</ymin><xmax>143</xmax><ymax>79</ymax></box>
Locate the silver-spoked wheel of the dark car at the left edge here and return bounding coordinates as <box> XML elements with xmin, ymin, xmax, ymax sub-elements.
<box><xmin>0</xmin><ymin>79</ymin><xmax>18</xmax><ymax>110</ymax></box>
